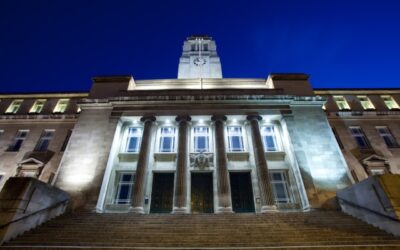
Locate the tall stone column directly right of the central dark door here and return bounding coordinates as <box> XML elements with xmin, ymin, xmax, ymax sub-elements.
<box><xmin>211</xmin><ymin>115</ymin><xmax>232</xmax><ymax>213</ymax></box>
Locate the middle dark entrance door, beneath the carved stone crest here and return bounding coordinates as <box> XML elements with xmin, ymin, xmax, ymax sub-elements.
<box><xmin>191</xmin><ymin>173</ymin><xmax>214</xmax><ymax>213</ymax></box>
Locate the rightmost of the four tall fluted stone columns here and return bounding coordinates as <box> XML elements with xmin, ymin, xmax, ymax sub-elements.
<box><xmin>247</xmin><ymin>115</ymin><xmax>276</xmax><ymax>213</ymax></box>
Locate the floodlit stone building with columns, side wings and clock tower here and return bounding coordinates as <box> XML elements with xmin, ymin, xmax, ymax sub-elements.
<box><xmin>0</xmin><ymin>36</ymin><xmax>400</xmax><ymax>213</ymax></box>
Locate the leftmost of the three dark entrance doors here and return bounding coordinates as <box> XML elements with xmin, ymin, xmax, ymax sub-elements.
<box><xmin>150</xmin><ymin>173</ymin><xmax>174</xmax><ymax>213</ymax></box>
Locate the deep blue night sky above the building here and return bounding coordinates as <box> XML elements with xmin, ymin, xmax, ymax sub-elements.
<box><xmin>0</xmin><ymin>0</ymin><xmax>400</xmax><ymax>93</ymax></box>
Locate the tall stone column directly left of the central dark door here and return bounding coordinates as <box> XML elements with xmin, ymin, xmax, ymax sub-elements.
<box><xmin>173</xmin><ymin>115</ymin><xmax>191</xmax><ymax>213</ymax></box>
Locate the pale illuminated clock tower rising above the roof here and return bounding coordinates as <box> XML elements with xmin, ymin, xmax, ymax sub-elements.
<box><xmin>178</xmin><ymin>35</ymin><xmax>222</xmax><ymax>79</ymax></box>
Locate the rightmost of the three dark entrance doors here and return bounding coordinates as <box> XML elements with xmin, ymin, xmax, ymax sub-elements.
<box><xmin>229</xmin><ymin>172</ymin><xmax>254</xmax><ymax>213</ymax></box>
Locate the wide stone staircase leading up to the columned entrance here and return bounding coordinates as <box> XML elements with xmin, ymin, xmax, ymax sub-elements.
<box><xmin>3</xmin><ymin>211</ymin><xmax>400</xmax><ymax>249</ymax></box>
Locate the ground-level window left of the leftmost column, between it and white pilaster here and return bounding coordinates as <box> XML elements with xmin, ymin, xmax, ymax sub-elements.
<box><xmin>114</xmin><ymin>172</ymin><xmax>135</xmax><ymax>204</ymax></box>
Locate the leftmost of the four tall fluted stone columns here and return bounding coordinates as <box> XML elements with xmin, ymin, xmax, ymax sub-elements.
<box><xmin>132</xmin><ymin>116</ymin><xmax>156</xmax><ymax>214</ymax></box>
